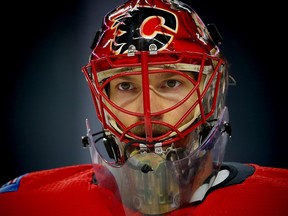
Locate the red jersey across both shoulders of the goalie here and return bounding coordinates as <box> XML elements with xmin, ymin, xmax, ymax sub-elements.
<box><xmin>0</xmin><ymin>163</ymin><xmax>288</xmax><ymax>216</ymax></box>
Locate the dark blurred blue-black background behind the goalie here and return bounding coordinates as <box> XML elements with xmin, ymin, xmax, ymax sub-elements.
<box><xmin>0</xmin><ymin>0</ymin><xmax>288</xmax><ymax>184</ymax></box>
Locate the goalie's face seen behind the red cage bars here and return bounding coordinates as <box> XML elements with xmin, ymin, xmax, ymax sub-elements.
<box><xmin>109</xmin><ymin>72</ymin><xmax>199</xmax><ymax>137</ymax></box>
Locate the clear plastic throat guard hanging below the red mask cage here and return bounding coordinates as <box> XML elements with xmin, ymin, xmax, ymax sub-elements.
<box><xmin>82</xmin><ymin>107</ymin><xmax>231</xmax><ymax>215</ymax></box>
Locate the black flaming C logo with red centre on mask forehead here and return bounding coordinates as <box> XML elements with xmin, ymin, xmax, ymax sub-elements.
<box><xmin>111</xmin><ymin>7</ymin><xmax>178</xmax><ymax>54</ymax></box>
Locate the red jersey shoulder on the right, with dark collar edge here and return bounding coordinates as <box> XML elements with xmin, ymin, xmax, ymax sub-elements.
<box><xmin>198</xmin><ymin>163</ymin><xmax>288</xmax><ymax>216</ymax></box>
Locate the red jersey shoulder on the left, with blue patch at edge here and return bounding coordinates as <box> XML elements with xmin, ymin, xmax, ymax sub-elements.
<box><xmin>0</xmin><ymin>164</ymin><xmax>124</xmax><ymax>216</ymax></box>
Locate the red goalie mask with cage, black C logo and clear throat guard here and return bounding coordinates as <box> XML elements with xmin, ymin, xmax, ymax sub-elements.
<box><xmin>83</xmin><ymin>0</ymin><xmax>230</xmax><ymax>215</ymax></box>
